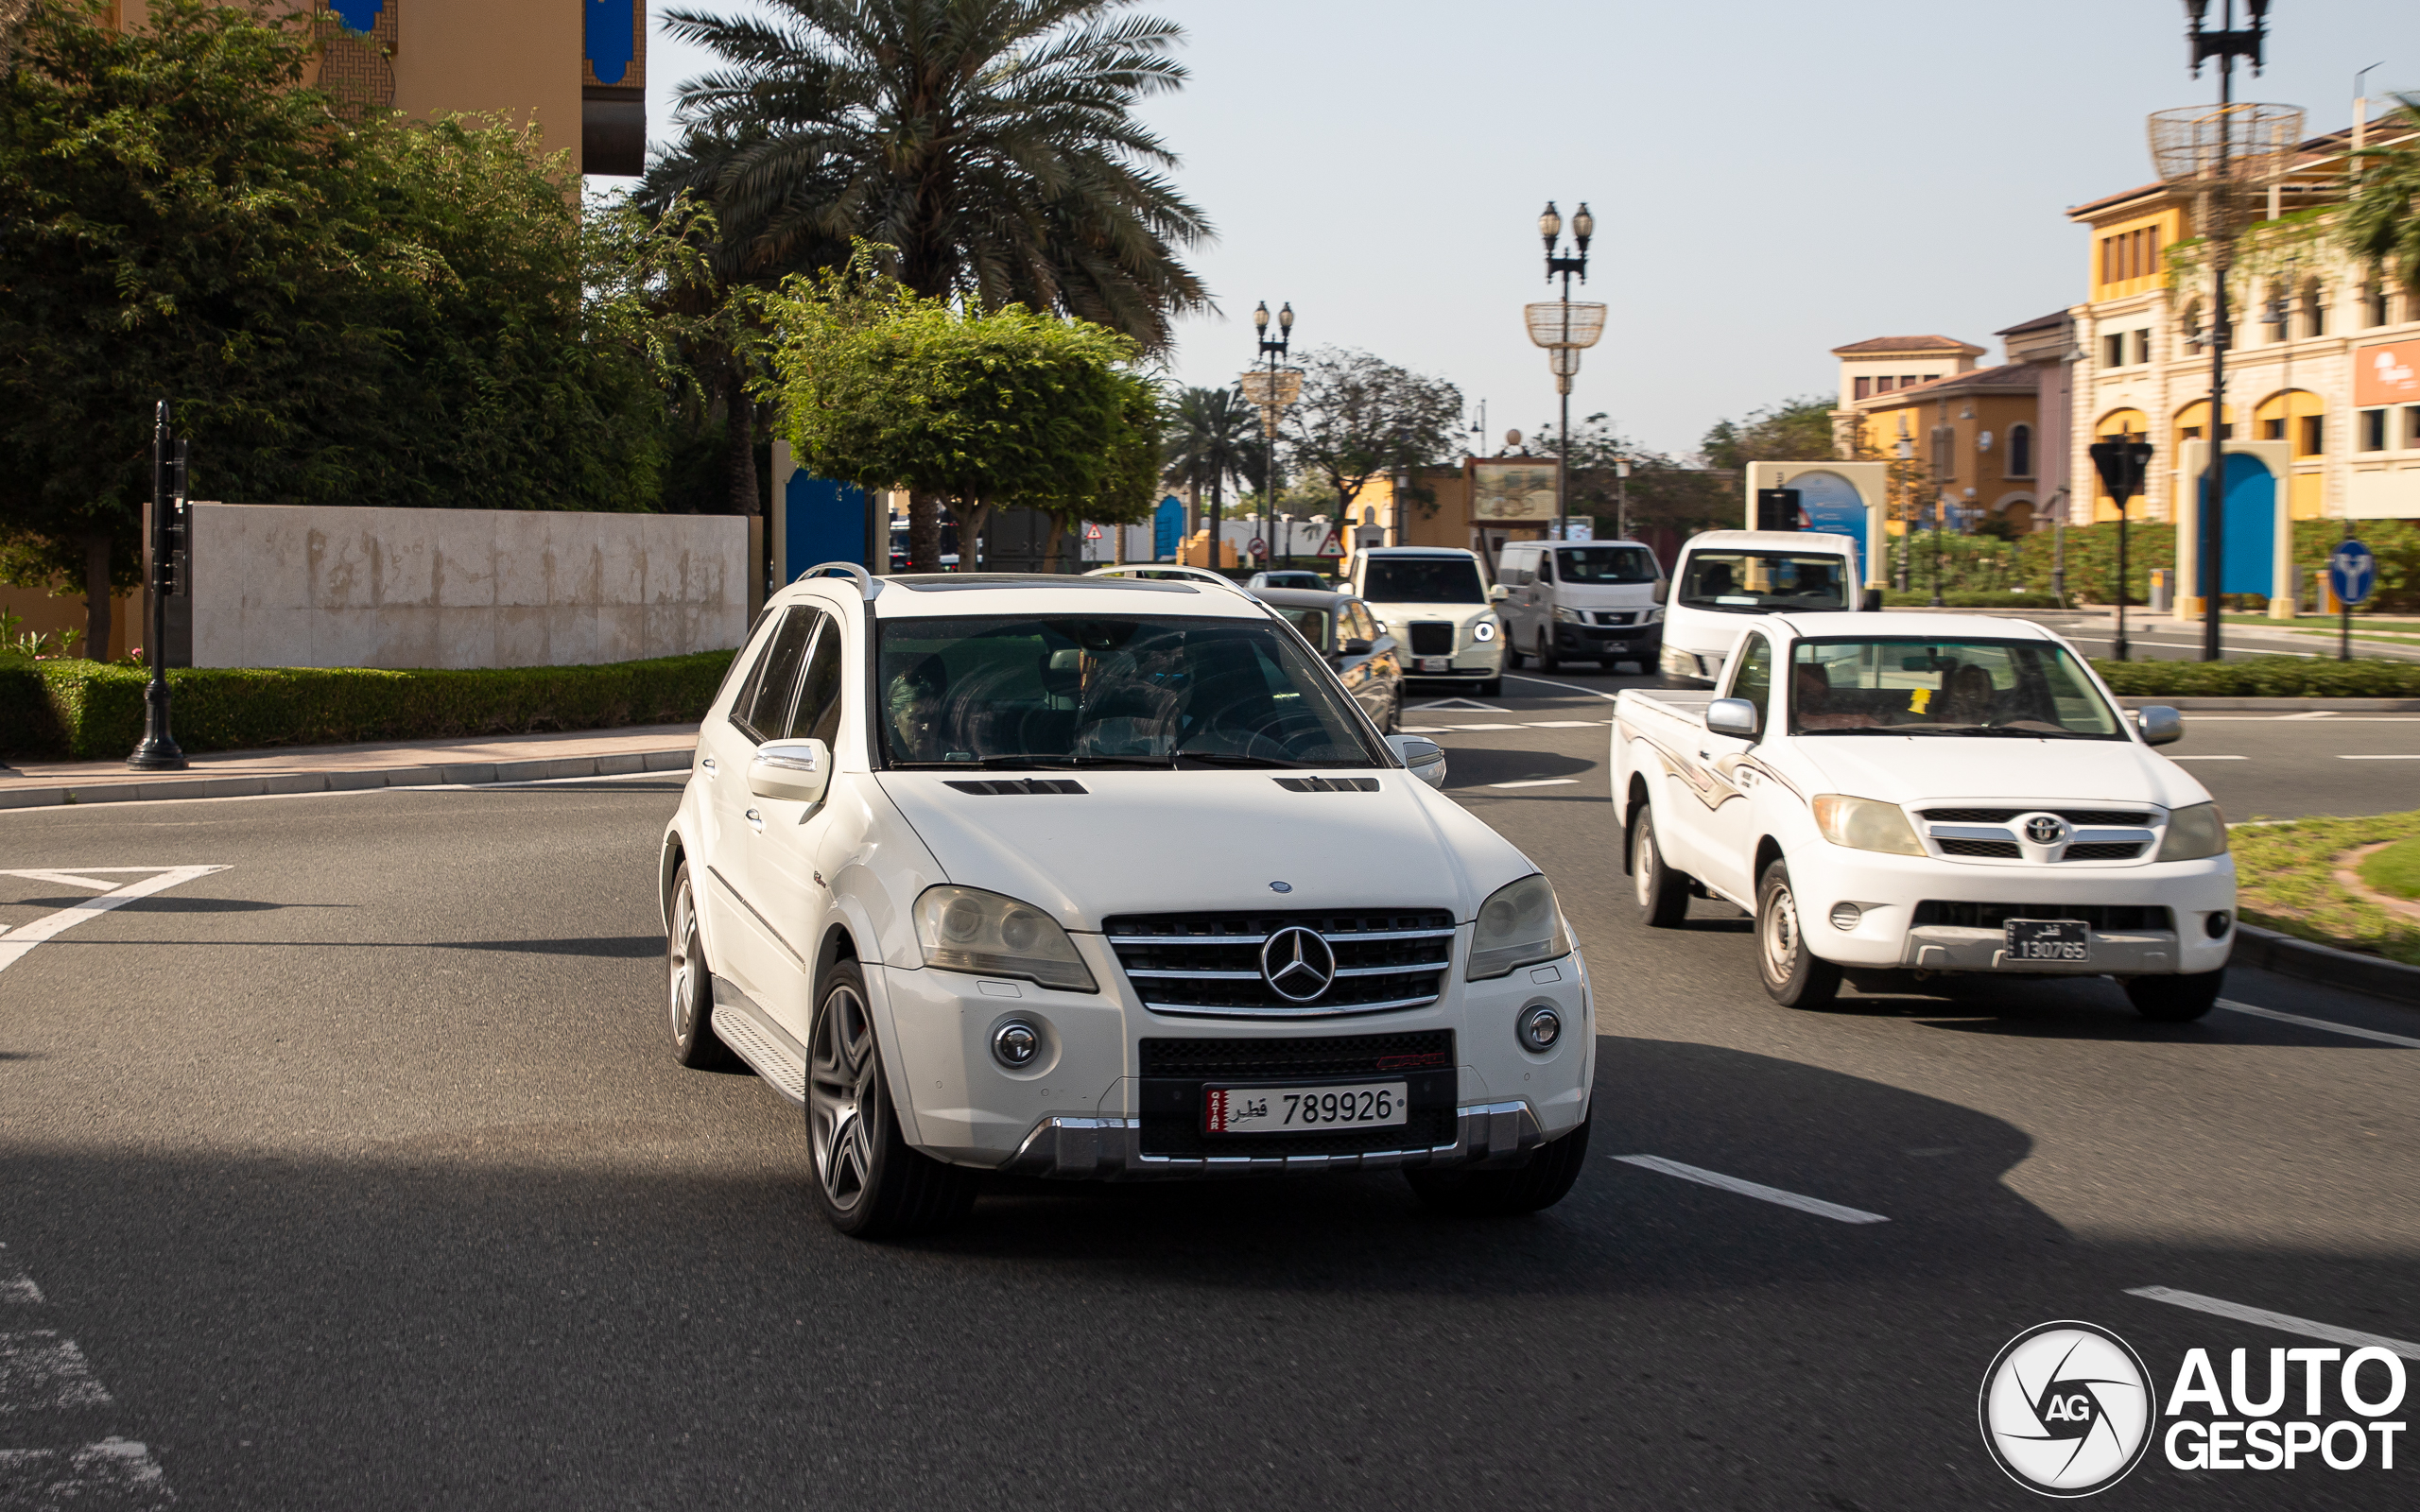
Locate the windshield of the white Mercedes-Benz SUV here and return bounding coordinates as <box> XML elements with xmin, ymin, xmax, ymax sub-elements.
<box><xmin>876</xmin><ymin>614</ymin><xmax>1379</xmax><ymax>767</ymax></box>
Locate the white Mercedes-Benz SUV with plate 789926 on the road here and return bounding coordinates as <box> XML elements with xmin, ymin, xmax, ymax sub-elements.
<box><xmin>658</xmin><ymin>569</ymin><xmax>1595</xmax><ymax>1236</ymax></box>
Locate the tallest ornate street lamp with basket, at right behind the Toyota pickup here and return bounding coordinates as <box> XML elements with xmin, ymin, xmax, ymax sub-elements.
<box><xmin>2152</xmin><ymin>0</ymin><xmax>2302</xmax><ymax>661</ymax></box>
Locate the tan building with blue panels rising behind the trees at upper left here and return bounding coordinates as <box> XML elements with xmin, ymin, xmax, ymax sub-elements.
<box><xmin>112</xmin><ymin>0</ymin><xmax>647</xmax><ymax>174</ymax></box>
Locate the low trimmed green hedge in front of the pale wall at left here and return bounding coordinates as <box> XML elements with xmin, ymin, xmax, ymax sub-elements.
<box><xmin>0</xmin><ymin>651</ymin><xmax>734</xmax><ymax>760</ymax></box>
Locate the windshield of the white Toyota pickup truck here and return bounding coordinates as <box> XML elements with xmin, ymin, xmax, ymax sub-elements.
<box><xmin>1790</xmin><ymin>636</ymin><xmax>2127</xmax><ymax>740</ymax></box>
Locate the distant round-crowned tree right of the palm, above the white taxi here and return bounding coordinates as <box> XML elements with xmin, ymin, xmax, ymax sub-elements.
<box><xmin>1278</xmin><ymin>349</ymin><xmax>1461</xmax><ymax>520</ymax></box>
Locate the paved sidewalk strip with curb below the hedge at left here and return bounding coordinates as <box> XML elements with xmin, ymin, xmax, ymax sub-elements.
<box><xmin>0</xmin><ymin>723</ymin><xmax>697</xmax><ymax>808</ymax></box>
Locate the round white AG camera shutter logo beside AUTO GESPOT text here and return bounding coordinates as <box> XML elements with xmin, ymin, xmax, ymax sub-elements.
<box><xmin>1975</xmin><ymin>1321</ymin><xmax>2159</xmax><ymax>1498</ymax></box>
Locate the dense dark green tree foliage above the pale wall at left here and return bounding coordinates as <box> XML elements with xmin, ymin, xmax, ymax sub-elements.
<box><xmin>0</xmin><ymin>0</ymin><xmax>663</xmax><ymax>646</ymax></box>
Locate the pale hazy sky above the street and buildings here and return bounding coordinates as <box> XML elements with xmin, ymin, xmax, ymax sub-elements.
<box><xmin>629</xmin><ymin>0</ymin><xmax>2420</xmax><ymax>455</ymax></box>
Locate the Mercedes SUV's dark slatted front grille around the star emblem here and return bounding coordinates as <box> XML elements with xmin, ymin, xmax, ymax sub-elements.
<box><xmin>1101</xmin><ymin>907</ymin><xmax>1455</xmax><ymax>1019</ymax></box>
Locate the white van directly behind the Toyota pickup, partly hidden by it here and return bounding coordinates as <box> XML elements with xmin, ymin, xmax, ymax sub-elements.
<box><xmin>1660</xmin><ymin>530</ymin><xmax>1880</xmax><ymax>684</ymax></box>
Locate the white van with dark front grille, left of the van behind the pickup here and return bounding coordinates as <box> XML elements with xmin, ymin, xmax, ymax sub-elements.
<box><xmin>1495</xmin><ymin>541</ymin><xmax>1665</xmax><ymax>673</ymax></box>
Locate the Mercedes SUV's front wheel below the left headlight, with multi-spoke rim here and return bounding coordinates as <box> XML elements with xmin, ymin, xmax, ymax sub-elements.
<box><xmin>805</xmin><ymin>960</ymin><xmax>980</xmax><ymax>1239</ymax></box>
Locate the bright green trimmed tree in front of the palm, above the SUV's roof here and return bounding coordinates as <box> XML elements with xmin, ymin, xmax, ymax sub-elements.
<box><xmin>768</xmin><ymin>247</ymin><xmax>1159</xmax><ymax>561</ymax></box>
